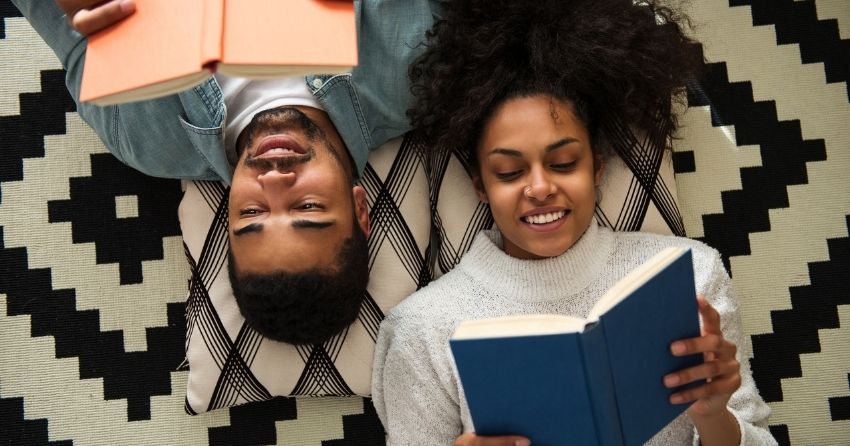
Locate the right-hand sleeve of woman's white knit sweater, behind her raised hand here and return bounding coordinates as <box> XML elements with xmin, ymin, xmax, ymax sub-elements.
<box><xmin>693</xmin><ymin>250</ymin><xmax>777</xmax><ymax>446</ymax></box>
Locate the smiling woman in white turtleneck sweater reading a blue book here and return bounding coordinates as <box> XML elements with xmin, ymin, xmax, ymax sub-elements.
<box><xmin>373</xmin><ymin>0</ymin><xmax>775</xmax><ymax>445</ymax></box>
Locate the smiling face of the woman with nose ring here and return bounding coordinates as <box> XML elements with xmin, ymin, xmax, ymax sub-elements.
<box><xmin>473</xmin><ymin>95</ymin><xmax>602</xmax><ymax>259</ymax></box>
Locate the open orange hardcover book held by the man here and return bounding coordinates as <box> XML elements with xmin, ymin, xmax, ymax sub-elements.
<box><xmin>80</xmin><ymin>0</ymin><xmax>357</xmax><ymax>105</ymax></box>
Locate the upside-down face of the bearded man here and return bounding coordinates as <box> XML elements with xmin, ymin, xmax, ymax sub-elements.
<box><xmin>228</xmin><ymin>106</ymin><xmax>369</xmax><ymax>276</ymax></box>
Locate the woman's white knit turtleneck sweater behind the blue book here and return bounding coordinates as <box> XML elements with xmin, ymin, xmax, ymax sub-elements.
<box><xmin>372</xmin><ymin>224</ymin><xmax>776</xmax><ymax>445</ymax></box>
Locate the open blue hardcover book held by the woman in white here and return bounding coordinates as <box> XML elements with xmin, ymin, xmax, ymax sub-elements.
<box><xmin>450</xmin><ymin>248</ymin><xmax>702</xmax><ymax>446</ymax></box>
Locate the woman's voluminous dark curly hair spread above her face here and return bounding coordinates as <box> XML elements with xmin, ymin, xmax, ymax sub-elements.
<box><xmin>408</xmin><ymin>0</ymin><xmax>702</xmax><ymax>168</ymax></box>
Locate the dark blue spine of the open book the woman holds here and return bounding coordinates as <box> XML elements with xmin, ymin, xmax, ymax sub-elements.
<box><xmin>580</xmin><ymin>322</ymin><xmax>625</xmax><ymax>446</ymax></box>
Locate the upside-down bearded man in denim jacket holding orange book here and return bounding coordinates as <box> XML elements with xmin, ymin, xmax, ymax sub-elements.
<box><xmin>13</xmin><ymin>0</ymin><xmax>438</xmax><ymax>344</ymax></box>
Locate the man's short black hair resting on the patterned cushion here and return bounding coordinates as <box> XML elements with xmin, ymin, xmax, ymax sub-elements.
<box><xmin>228</xmin><ymin>221</ymin><xmax>369</xmax><ymax>345</ymax></box>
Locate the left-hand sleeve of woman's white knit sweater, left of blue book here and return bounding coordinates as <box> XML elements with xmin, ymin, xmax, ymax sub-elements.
<box><xmin>372</xmin><ymin>308</ymin><xmax>463</xmax><ymax>446</ymax></box>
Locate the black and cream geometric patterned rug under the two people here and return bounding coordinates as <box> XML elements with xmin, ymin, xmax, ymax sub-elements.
<box><xmin>0</xmin><ymin>0</ymin><xmax>850</xmax><ymax>445</ymax></box>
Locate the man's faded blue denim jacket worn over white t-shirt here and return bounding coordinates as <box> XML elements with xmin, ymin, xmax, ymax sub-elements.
<box><xmin>12</xmin><ymin>0</ymin><xmax>440</xmax><ymax>184</ymax></box>
